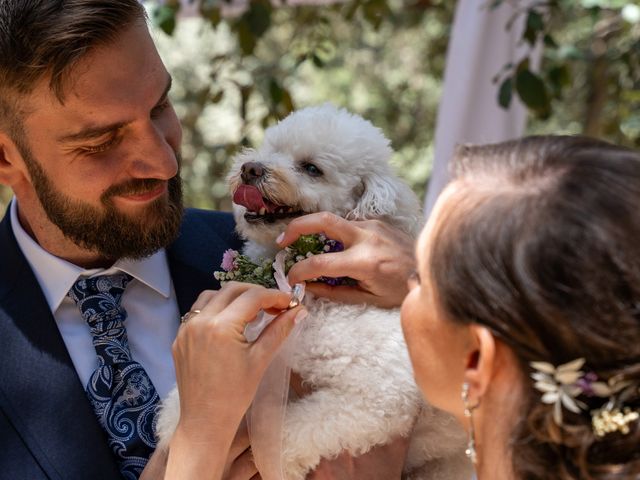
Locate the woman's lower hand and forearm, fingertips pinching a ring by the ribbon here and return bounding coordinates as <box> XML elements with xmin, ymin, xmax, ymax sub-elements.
<box><xmin>165</xmin><ymin>282</ymin><xmax>304</xmax><ymax>479</ymax></box>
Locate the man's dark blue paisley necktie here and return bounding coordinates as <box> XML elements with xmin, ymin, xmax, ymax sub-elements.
<box><xmin>68</xmin><ymin>273</ymin><xmax>159</xmax><ymax>479</ymax></box>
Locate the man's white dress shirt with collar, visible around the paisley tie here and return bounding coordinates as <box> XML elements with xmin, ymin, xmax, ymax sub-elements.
<box><xmin>10</xmin><ymin>198</ymin><xmax>180</xmax><ymax>398</ymax></box>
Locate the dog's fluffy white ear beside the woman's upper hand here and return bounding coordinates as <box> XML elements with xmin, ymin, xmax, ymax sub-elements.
<box><xmin>346</xmin><ymin>172</ymin><xmax>422</xmax><ymax>233</ymax></box>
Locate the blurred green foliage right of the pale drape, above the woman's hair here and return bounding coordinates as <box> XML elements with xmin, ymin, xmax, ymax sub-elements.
<box><xmin>492</xmin><ymin>0</ymin><xmax>640</xmax><ymax>147</ymax></box>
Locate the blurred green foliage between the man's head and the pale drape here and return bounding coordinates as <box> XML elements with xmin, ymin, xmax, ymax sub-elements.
<box><xmin>151</xmin><ymin>0</ymin><xmax>454</xmax><ymax>209</ymax></box>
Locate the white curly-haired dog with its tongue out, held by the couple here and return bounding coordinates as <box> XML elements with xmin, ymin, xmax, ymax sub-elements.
<box><xmin>158</xmin><ymin>104</ymin><xmax>471</xmax><ymax>480</ymax></box>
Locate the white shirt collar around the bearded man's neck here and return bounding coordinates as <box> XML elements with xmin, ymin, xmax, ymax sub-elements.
<box><xmin>9</xmin><ymin>197</ymin><xmax>171</xmax><ymax>312</ymax></box>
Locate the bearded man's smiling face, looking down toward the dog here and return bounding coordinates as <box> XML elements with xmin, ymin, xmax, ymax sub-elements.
<box><xmin>16</xmin><ymin>22</ymin><xmax>182</xmax><ymax>259</ymax></box>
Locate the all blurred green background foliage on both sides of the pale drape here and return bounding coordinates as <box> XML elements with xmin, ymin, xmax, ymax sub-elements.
<box><xmin>0</xmin><ymin>0</ymin><xmax>640</xmax><ymax>211</ymax></box>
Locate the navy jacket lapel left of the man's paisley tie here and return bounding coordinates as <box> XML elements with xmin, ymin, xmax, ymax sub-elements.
<box><xmin>0</xmin><ymin>213</ymin><xmax>120</xmax><ymax>479</ymax></box>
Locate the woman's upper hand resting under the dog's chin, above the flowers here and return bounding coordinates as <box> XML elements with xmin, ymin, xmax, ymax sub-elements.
<box><xmin>278</xmin><ymin>212</ymin><xmax>415</xmax><ymax>308</ymax></box>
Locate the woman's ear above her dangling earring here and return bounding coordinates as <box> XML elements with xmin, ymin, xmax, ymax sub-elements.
<box><xmin>464</xmin><ymin>324</ymin><xmax>497</xmax><ymax>405</ymax></box>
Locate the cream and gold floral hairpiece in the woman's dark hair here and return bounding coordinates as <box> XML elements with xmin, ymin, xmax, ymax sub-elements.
<box><xmin>529</xmin><ymin>358</ymin><xmax>640</xmax><ymax>438</ymax></box>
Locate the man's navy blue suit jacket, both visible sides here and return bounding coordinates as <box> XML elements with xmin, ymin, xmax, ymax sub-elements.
<box><xmin>0</xmin><ymin>210</ymin><xmax>240</xmax><ymax>480</ymax></box>
